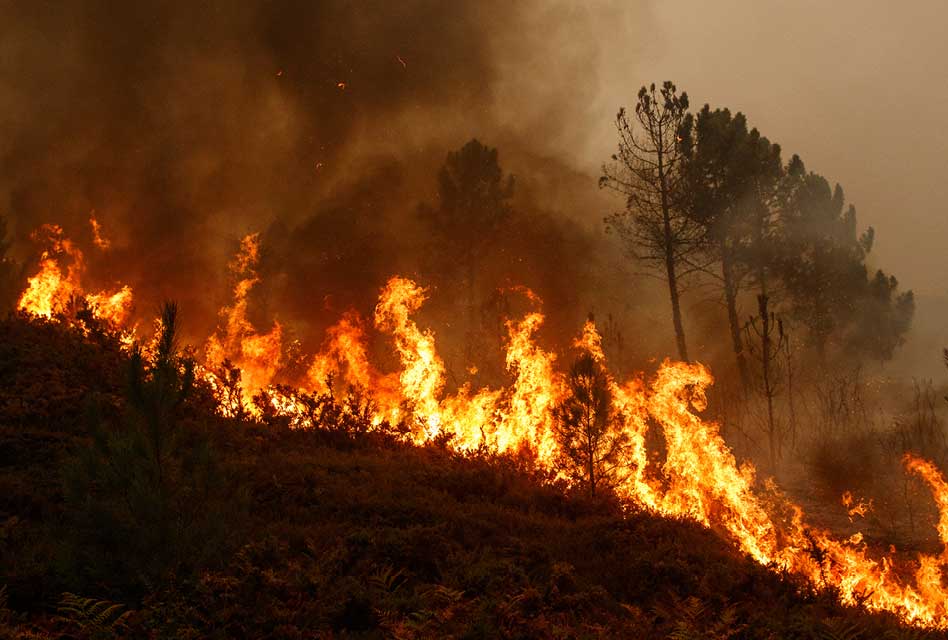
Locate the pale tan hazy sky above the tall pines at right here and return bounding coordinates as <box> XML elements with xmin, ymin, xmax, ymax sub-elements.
<box><xmin>588</xmin><ymin>0</ymin><xmax>948</xmax><ymax>294</ymax></box>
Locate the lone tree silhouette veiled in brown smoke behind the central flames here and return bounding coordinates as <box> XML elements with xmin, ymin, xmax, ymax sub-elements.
<box><xmin>420</xmin><ymin>139</ymin><xmax>514</xmax><ymax>308</ymax></box>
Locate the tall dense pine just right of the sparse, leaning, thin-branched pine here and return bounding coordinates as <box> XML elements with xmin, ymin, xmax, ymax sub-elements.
<box><xmin>681</xmin><ymin>105</ymin><xmax>782</xmax><ymax>387</ymax></box>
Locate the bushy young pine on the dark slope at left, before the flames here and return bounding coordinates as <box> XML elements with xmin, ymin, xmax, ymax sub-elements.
<box><xmin>64</xmin><ymin>304</ymin><xmax>233</xmax><ymax>584</ymax></box>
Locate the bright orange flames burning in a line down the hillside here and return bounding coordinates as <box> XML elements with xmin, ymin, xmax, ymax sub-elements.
<box><xmin>14</xmin><ymin>226</ymin><xmax>948</xmax><ymax>628</ymax></box>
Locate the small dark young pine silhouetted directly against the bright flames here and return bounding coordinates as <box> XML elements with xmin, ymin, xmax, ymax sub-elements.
<box><xmin>553</xmin><ymin>352</ymin><xmax>628</xmax><ymax>497</ymax></box>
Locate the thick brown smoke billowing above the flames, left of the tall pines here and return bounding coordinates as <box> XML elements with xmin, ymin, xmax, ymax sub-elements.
<box><xmin>0</xmin><ymin>0</ymin><xmax>668</xmax><ymax>370</ymax></box>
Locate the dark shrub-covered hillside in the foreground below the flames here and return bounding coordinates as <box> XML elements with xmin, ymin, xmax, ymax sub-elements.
<box><xmin>0</xmin><ymin>318</ymin><xmax>942</xmax><ymax>638</ymax></box>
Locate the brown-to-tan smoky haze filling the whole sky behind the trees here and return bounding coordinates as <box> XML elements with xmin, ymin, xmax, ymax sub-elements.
<box><xmin>0</xmin><ymin>0</ymin><xmax>948</xmax><ymax>370</ymax></box>
